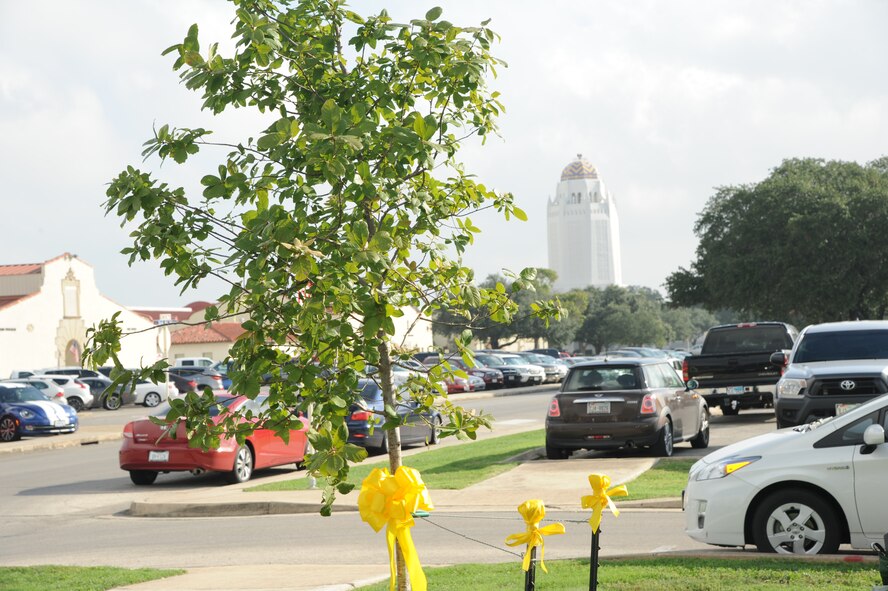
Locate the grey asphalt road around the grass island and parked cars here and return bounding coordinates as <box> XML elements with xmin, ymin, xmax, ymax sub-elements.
<box><xmin>0</xmin><ymin>393</ymin><xmax>775</xmax><ymax>567</ymax></box>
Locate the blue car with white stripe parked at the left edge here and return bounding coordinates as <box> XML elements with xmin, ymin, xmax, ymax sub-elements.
<box><xmin>0</xmin><ymin>383</ymin><xmax>78</xmax><ymax>441</ymax></box>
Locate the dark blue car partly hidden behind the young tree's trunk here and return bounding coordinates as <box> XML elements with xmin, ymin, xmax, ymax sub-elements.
<box><xmin>346</xmin><ymin>380</ymin><xmax>441</xmax><ymax>453</ymax></box>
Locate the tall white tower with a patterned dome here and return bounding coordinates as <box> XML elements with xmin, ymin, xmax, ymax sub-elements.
<box><xmin>548</xmin><ymin>154</ymin><xmax>623</xmax><ymax>291</ymax></box>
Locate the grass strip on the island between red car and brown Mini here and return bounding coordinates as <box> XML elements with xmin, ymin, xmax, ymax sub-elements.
<box><xmin>247</xmin><ymin>430</ymin><xmax>545</xmax><ymax>491</ymax></box>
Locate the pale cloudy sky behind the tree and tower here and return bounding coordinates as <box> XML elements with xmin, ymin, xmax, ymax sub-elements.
<box><xmin>0</xmin><ymin>0</ymin><xmax>888</xmax><ymax>306</ymax></box>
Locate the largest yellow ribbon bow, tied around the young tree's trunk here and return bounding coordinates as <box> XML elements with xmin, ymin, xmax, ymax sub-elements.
<box><xmin>358</xmin><ymin>466</ymin><xmax>434</xmax><ymax>591</ymax></box>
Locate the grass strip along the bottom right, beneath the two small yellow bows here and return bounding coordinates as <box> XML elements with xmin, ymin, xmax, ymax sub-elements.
<box><xmin>352</xmin><ymin>557</ymin><xmax>880</xmax><ymax>591</ymax></box>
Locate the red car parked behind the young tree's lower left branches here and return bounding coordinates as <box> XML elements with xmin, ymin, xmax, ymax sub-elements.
<box><xmin>120</xmin><ymin>395</ymin><xmax>308</xmax><ymax>485</ymax></box>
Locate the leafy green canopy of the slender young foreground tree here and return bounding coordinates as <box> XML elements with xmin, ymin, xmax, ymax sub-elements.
<box><xmin>89</xmin><ymin>0</ymin><xmax>556</xmax><ymax>536</ymax></box>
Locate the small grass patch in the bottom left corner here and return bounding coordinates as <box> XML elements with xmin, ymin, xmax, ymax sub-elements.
<box><xmin>0</xmin><ymin>566</ymin><xmax>185</xmax><ymax>591</ymax></box>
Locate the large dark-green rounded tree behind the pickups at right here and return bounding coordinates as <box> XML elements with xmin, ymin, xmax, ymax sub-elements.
<box><xmin>666</xmin><ymin>158</ymin><xmax>888</xmax><ymax>323</ymax></box>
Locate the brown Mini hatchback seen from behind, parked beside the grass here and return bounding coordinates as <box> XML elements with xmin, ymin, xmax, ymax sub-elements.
<box><xmin>546</xmin><ymin>358</ymin><xmax>709</xmax><ymax>460</ymax></box>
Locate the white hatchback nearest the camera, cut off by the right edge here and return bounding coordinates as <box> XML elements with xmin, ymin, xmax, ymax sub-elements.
<box><xmin>682</xmin><ymin>395</ymin><xmax>888</xmax><ymax>554</ymax></box>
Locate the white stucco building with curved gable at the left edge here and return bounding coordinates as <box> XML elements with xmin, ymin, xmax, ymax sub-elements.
<box><xmin>0</xmin><ymin>253</ymin><xmax>161</xmax><ymax>377</ymax></box>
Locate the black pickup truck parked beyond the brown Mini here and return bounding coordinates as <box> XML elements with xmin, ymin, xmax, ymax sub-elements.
<box><xmin>682</xmin><ymin>322</ymin><xmax>799</xmax><ymax>416</ymax></box>
